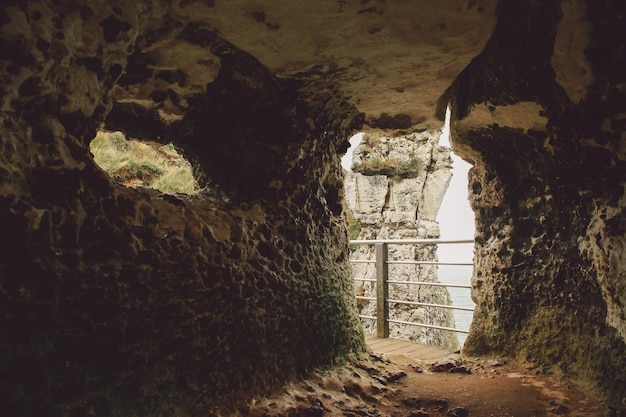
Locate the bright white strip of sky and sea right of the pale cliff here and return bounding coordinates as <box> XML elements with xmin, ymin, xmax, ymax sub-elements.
<box><xmin>437</xmin><ymin>107</ymin><xmax>475</xmax><ymax>347</ymax></box>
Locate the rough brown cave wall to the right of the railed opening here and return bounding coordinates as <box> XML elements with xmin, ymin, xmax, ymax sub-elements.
<box><xmin>450</xmin><ymin>1</ymin><xmax>626</xmax><ymax>410</ymax></box>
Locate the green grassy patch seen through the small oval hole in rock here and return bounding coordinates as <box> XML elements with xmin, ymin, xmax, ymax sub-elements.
<box><xmin>89</xmin><ymin>131</ymin><xmax>198</xmax><ymax>194</ymax></box>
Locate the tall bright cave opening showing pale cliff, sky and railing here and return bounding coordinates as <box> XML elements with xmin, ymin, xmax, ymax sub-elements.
<box><xmin>341</xmin><ymin>112</ymin><xmax>474</xmax><ymax>350</ymax></box>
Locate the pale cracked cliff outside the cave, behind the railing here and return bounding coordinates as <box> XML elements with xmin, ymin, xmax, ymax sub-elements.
<box><xmin>344</xmin><ymin>131</ymin><xmax>458</xmax><ymax>349</ymax></box>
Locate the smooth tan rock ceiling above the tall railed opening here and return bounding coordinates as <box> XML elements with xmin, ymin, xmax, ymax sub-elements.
<box><xmin>109</xmin><ymin>0</ymin><xmax>496</xmax><ymax>130</ymax></box>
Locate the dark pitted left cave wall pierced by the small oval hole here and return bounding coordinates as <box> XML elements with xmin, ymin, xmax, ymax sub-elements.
<box><xmin>0</xmin><ymin>2</ymin><xmax>365</xmax><ymax>416</ymax></box>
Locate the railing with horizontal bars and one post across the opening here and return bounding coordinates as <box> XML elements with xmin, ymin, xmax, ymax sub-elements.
<box><xmin>350</xmin><ymin>239</ymin><xmax>474</xmax><ymax>338</ymax></box>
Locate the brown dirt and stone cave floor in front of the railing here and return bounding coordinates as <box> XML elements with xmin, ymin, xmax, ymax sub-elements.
<box><xmin>237</xmin><ymin>355</ymin><xmax>610</xmax><ymax>417</ymax></box>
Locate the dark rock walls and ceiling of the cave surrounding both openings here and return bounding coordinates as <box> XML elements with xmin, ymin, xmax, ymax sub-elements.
<box><xmin>0</xmin><ymin>0</ymin><xmax>626</xmax><ymax>416</ymax></box>
